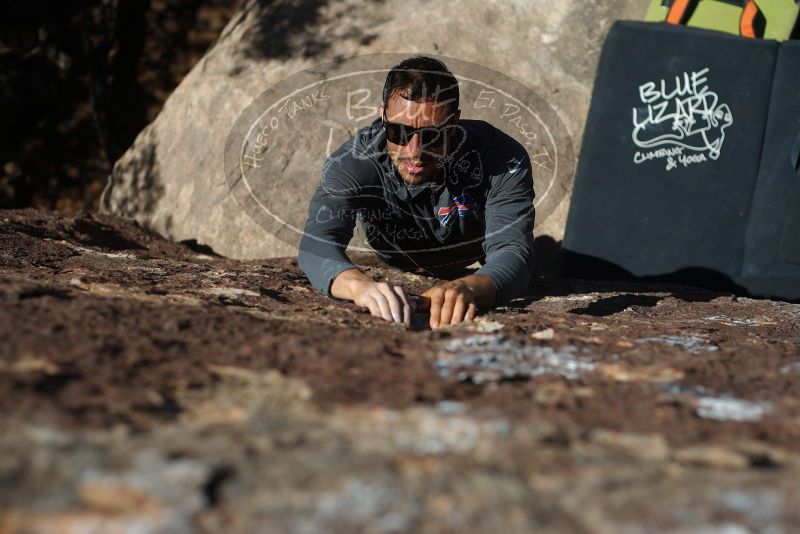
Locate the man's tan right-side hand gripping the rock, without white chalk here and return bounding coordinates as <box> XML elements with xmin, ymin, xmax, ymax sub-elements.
<box><xmin>422</xmin><ymin>274</ymin><xmax>496</xmax><ymax>328</ymax></box>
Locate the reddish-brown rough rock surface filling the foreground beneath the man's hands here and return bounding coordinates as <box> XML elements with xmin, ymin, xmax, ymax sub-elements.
<box><xmin>0</xmin><ymin>210</ymin><xmax>800</xmax><ymax>533</ymax></box>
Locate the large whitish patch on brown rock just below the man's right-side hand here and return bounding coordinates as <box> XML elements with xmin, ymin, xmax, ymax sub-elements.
<box><xmin>434</xmin><ymin>334</ymin><xmax>596</xmax><ymax>384</ymax></box>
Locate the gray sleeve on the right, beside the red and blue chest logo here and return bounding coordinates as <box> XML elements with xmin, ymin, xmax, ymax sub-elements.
<box><xmin>475</xmin><ymin>145</ymin><xmax>535</xmax><ymax>306</ymax></box>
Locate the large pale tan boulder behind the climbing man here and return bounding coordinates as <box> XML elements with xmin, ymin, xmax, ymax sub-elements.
<box><xmin>100</xmin><ymin>0</ymin><xmax>646</xmax><ymax>258</ymax></box>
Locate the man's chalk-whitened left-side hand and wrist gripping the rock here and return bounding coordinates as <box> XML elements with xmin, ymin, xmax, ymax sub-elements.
<box><xmin>331</xmin><ymin>269</ymin><xmax>414</xmax><ymax>326</ymax></box>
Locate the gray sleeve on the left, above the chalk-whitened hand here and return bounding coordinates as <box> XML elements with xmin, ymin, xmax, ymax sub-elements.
<box><xmin>297</xmin><ymin>165</ymin><xmax>358</xmax><ymax>298</ymax></box>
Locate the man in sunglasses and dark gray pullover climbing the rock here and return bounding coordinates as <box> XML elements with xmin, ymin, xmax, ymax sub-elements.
<box><xmin>298</xmin><ymin>56</ymin><xmax>534</xmax><ymax>328</ymax></box>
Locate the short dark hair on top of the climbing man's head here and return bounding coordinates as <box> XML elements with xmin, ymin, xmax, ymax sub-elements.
<box><xmin>383</xmin><ymin>56</ymin><xmax>459</xmax><ymax>112</ymax></box>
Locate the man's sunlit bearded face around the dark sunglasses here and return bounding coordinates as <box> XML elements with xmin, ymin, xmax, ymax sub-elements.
<box><xmin>380</xmin><ymin>94</ymin><xmax>461</xmax><ymax>185</ymax></box>
